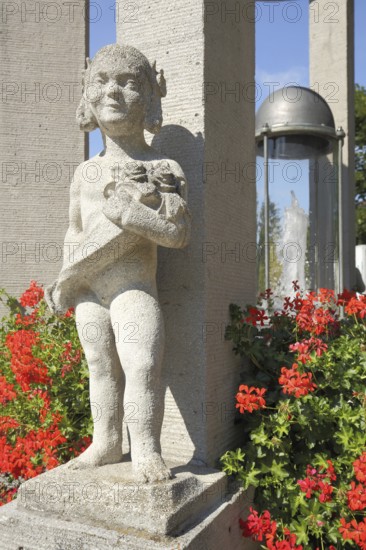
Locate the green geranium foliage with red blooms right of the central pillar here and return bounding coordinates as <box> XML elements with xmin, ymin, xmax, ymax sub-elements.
<box><xmin>221</xmin><ymin>291</ymin><xmax>366</xmax><ymax>550</ymax></box>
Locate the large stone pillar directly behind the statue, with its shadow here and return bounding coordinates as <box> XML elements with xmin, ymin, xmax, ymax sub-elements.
<box><xmin>117</xmin><ymin>0</ymin><xmax>256</xmax><ymax>465</ymax></box>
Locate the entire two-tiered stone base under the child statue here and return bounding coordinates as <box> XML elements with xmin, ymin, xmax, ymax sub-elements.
<box><xmin>0</xmin><ymin>463</ymin><xmax>258</xmax><ymax>550</ymax></box>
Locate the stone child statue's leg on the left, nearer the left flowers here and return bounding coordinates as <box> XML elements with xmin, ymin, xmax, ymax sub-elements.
<box><xmin>64</xmin><ymin>295</ymin><xmax>124</xmax><ymax>469</ymax></box>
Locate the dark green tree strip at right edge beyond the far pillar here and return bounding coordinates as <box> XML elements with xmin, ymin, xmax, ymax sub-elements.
<box><xmin>355</xmin><ymin>84</ymin><xmax>366</xmax><ymax>244</ymax></box>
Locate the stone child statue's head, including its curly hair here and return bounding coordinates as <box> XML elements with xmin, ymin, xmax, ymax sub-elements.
<box><xmin>76</xmin><ymin>44</ymin><xmax>166</xmax><ymax>134</ymax></box>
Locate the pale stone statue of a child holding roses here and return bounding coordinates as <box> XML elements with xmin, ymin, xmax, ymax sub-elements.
<box><xmin>46</xmin><ymin>45</ymin><xmax>190</xmax><ymax>482</ymax></box>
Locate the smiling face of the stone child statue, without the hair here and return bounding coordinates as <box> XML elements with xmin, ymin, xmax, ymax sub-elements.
<box><xmin>87</xmin><ymin>60</ymin><xmax>147</xmax><ymax>136</ymax></box>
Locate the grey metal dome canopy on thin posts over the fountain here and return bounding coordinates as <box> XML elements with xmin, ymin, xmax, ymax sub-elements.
<box><xmin>255</xmin><ymin>86</ymin><xmax>345</xmax><ymax>291</ymax></box>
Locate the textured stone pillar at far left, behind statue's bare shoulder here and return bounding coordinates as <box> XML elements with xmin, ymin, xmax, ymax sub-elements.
<box><xmin>0</xmin><ymin>0</ymin><xmax>88</xmax><ymax>302</ymax></box>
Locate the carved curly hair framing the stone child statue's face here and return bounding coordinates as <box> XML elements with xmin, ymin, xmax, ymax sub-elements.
<box><xmin>76</xmin><ymin>44</ymin><xmax>166</xmax><ymax>134</ymax></box>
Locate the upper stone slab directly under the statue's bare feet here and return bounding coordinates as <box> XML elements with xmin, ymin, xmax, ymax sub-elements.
<box><xmin>17</xmin><ymin>462</ymin><xmax>227</xmax><ymax>535</ymax></box>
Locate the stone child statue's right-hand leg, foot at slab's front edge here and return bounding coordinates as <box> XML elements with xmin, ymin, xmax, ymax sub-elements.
<box><xmin>110</xmin><ymin>290</ymin><xmax>171</xmax><ymax>482</ymax></box>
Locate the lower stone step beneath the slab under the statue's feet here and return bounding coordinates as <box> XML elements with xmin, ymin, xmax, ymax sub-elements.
<box><xmin>0</xmin><ymin>480</ymin><xmax>258</xmax><ymax>550</ymax></box>
